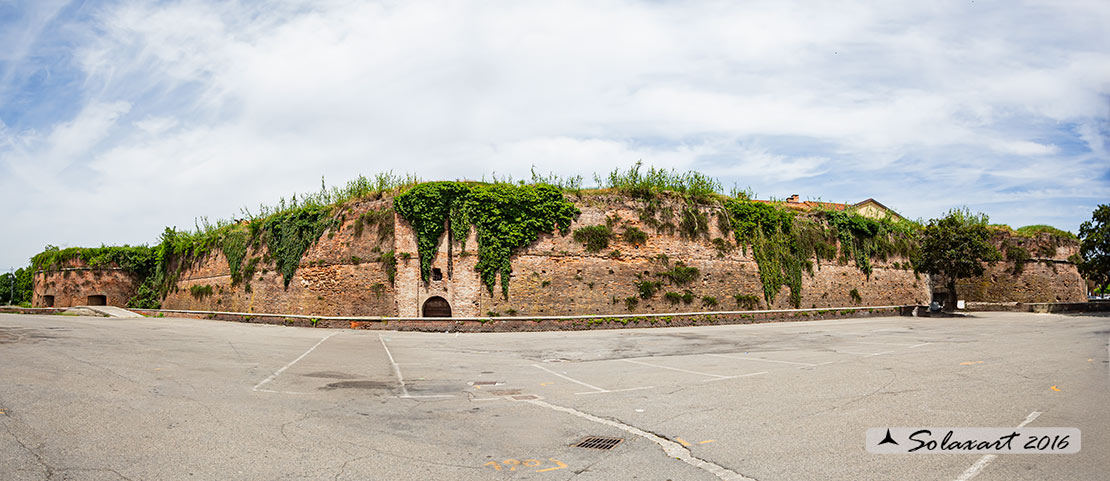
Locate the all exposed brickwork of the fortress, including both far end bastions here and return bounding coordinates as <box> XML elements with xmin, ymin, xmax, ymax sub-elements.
<box><xmin>34</xmin><ymin>193</ymin><xmax>1086</xmax><ymax>313</ymax></box>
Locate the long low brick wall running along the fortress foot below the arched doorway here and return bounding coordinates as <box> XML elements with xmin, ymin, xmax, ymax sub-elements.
<box><xmin>133</xmin><ymin>305</ymin><xmax>910</xmax><ymax>332</ymax></box>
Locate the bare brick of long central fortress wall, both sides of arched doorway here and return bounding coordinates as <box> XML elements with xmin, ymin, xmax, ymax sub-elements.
<box><xmin>163</xmin><ymin>194</ymin><xmax>929</xmax><ymax>317</ymax></box>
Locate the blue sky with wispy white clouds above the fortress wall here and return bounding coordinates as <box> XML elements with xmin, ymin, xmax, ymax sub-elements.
<box><xmin>0</xmin><ymin>0</ymin><xmax>1110</xmax><ymax>270</ymax></box>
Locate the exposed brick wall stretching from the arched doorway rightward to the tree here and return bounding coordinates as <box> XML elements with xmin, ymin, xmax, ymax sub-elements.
<box><xmin>441</xmin><ymin>194</ymin><xmax>929</xmax><ymax>315</ymax></box>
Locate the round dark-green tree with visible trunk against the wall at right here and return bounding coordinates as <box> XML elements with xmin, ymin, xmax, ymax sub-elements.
<box><xmin>917</xmin><ymin>208</ymin><xmax>1001</xmax><ymax>310</ymax></box>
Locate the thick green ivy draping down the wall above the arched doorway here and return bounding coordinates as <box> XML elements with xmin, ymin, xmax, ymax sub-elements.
<box><xmin>393</xmin><ymin>182</ymin><xmax>579</xmax><ymax>297</ymax></box>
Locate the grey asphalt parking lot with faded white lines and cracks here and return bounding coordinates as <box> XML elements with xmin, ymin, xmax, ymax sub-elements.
<box><xmin>0</xmin><ymin>313</ymin><xmax>1110</xmax><ymax>481</ymax></box>
